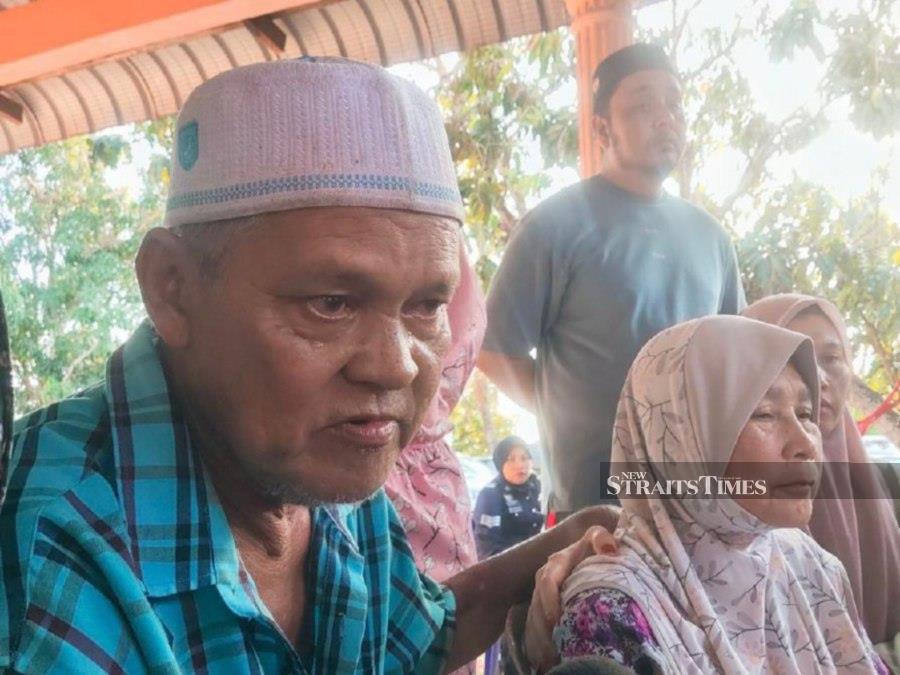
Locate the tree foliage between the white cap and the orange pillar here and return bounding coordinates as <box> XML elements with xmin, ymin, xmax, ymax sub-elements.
<box><xmin>432</xmin><ymin>31</ymin><xmax>578</xmax><ymax>287</ymax></box>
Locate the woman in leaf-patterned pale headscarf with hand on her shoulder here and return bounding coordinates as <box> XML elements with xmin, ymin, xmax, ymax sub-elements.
<box><xmin>555</xmin><ymin>316</ymin><xmax>887</xmax><ymax>675</ymax></box>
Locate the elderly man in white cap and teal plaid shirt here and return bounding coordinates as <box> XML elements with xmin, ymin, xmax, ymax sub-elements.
<box><xmin>0</xmin><ymin>59</ymin><xmax>616</xmax><ymax>674</ymax></box>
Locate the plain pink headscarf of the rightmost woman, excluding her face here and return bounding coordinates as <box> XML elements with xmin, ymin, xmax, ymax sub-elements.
<box><xmin>742</xmin><ymin>293</ymin><xmax>900</xmax><ymax>642</ymax></box>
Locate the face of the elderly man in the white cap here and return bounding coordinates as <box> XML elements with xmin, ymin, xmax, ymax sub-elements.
<box><xmin>177</xmin><ymin>207</ymin><xmax>460</xmax><ymax>504</ymax></box>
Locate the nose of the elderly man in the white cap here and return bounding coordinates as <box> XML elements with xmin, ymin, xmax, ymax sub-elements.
<box><xmin>344</xmin><ymin>317</ymin><xmax>419</xmax><ymax>390</ymax></box>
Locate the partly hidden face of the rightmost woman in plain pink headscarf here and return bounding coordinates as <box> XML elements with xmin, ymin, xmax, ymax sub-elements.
<box><xmin>787</xmin><ymin>310</ymin><xmax>851</xmax><ymax>435</ymax></box>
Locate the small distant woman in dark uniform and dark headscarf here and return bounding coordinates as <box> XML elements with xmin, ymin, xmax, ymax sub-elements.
<box><xmin>472</xmin><ymin>436</ymin><xmax>544</xmax><ymax>560</ymax></box>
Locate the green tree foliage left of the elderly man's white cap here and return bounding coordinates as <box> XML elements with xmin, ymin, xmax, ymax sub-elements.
<box><xmin>0</xmin><ymin>122</ymin><xmax>174</xmax><ymax>413</ymax></box>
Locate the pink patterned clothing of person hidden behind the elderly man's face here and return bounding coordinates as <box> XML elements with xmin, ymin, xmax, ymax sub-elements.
<box><xmin>384</xmin><ymin>250</ymin><xmax>486</xmax><ymax>581</ymax></box>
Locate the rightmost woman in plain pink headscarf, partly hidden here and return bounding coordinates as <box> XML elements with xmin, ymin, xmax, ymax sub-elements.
<box><xmin>743</xmin><ymin>293</ymin><xmax>900</xmax><ymax>656</ymax></box>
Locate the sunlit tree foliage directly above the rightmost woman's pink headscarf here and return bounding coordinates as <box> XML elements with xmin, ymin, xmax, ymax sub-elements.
<box><xmin>739</xmin><ymin>178</ymin><xmax>900</xmax><ymax>392</ymax></box>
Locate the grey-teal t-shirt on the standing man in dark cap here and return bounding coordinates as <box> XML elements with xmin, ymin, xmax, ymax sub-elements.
<box><xmin>484</xmin><ymin>176</ymin><xmax>745</xmax><ymax>511</ymax></box>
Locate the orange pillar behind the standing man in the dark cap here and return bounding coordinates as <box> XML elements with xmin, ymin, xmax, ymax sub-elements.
<box><xmin>566</xmin><ymin>0</ymin><xmax>634</xmax><ymax>178</ymax></box>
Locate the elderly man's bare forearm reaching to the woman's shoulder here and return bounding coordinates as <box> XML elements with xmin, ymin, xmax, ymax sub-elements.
<box><xmin>445</xmin><ymin>506</ymin><xmax>619</xmax><ymax>672</ymax></box>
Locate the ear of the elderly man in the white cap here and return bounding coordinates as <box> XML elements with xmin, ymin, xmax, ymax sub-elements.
<box><xmin>134</xmin><ymin>227</ymin><xmax>197</xmax><ymax>349</ymax></box>
